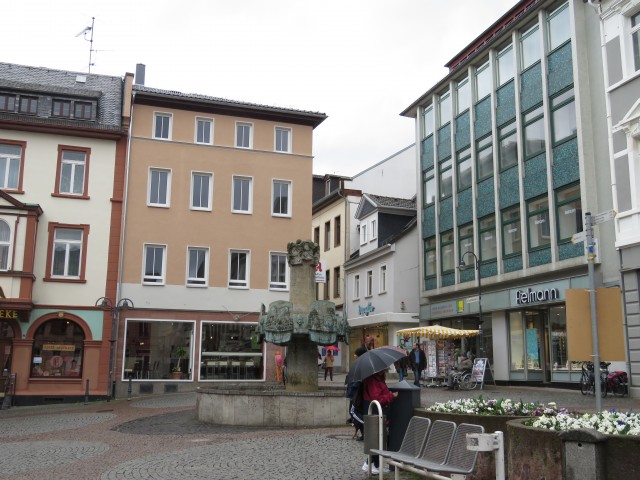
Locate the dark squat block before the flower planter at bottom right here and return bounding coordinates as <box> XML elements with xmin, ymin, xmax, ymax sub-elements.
<box><xmin>560</xmin><ymin>430</ymin><xmax>607</xmax><ymax>480</ymax></box>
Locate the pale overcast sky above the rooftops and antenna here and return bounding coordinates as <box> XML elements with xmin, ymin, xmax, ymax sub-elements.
<box><xmin>0</xmin><ymin>0</ymin><xmax>517</xmax><ymax>175</ymax></box>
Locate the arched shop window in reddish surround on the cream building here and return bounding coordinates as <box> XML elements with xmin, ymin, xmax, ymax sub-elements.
<box><xmin>31</xmin><ymin>318</ymin><xmax>85</xmax><ymax>378</ymax></box>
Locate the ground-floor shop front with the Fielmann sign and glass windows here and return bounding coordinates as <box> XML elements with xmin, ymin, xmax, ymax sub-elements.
<box><xmin>423</xmin><ymin>276</ymin><xmax>588</xmax><ymax>384</ymax></box>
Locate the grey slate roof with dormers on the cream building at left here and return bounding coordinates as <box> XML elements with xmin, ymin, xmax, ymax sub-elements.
<box><xmin>0</xmin><ymin>62</ymin><xmax>124</xmax><ymax>130</ymax></box>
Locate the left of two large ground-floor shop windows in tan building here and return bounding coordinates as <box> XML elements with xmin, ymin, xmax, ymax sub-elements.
<box><xmin>122</xmin><ymin>320</ymin><xmax>194</xmax><ymax>380</ymax></box>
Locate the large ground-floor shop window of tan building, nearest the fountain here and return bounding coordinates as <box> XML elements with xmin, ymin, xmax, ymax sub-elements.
<box><xmin>199</xmin><ymin>322</ymin><xmax>262</xmax><ymax>381</ymax></box>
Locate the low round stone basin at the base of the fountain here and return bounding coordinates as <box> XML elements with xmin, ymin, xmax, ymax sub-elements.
<box><xmin>196</xmin><ymin>385</ymin><xmax>349</xmax><ymax>428</ymax></box>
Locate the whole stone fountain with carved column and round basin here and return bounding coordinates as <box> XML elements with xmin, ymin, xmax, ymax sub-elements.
<box><xmin>196</xmin><ymin>240</ymin><xmax>349</xmax><ymax>427</ymax></box>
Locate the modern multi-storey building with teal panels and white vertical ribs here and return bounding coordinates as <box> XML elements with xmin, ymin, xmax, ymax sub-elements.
<box><xmin>402</xmin><ymin>0</ymin><xmax>622</xmax><ymax>383</ymax></box>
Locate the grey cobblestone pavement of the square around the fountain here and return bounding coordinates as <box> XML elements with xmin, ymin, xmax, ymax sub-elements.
<box><xmin>0</xmin><ymin>375</ymin><xmax>640</xmax><ymax>480</ymax></box>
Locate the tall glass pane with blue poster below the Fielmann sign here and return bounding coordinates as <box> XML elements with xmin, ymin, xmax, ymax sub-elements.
<box><xmin>509</xmin><ymin>309</ymin><xmax>549</xmax><ymax>382</ymax></box>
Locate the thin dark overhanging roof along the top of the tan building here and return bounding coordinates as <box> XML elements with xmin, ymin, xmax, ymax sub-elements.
<box><xmin>133</xmin><ymin>84</ymin><xmax>327</xmax><ymax>128</ymax></box>
